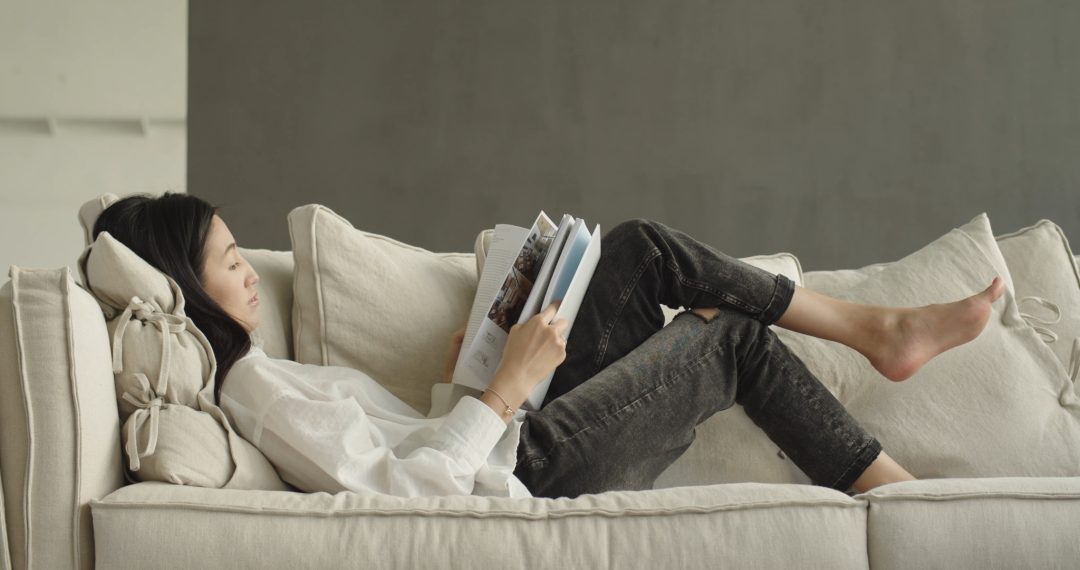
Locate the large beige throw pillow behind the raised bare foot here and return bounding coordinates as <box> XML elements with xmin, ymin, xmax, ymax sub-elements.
<box><xmin>778</xmin><ymin>213</ymin><xmax>1080</xmax><ymax>478</ymax></box>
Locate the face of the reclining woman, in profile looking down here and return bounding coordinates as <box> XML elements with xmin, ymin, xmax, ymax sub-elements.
<box><xmin>202</xmin><ymin>214</ymin><xmax>259</xmax><ymax>333</ymax></box>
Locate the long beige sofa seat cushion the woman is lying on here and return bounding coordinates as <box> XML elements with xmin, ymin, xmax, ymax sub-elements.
<box><xmin>91</xmin><ymin>483</ymin><xmax>867</xmax><ymax>569</ymax></box>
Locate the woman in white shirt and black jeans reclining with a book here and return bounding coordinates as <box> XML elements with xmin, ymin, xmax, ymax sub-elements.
<box><xmin>93</xmin><ymin>193</ymin><xmax>1004</xmax><ymax>498</ymax></box>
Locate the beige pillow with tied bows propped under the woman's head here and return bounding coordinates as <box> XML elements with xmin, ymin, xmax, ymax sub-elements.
<box><xmin>78</xmin><ymin>228</ymin><xmax>288</xmax><ymax>489</ymax></box>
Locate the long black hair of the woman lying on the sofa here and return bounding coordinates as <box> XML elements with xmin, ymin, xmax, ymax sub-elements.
<box><xmin>92</xmin><ymin>192</ymin><xmax>252</xmax><ymax>404</ymax></box>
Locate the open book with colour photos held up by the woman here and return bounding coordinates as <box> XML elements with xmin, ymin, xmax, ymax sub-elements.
<box><xmin>428</xmin><ymin>212</ymin><xmax>600</xmax><ymax>417</ymax></box>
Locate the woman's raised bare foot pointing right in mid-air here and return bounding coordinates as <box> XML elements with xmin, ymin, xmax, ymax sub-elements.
<box><xmin>863</xmin><ymin>277</ymin><xmax>1004</xmax><ymax>382</ymax></box>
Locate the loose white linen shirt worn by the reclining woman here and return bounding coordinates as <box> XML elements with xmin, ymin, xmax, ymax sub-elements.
<box><xmin>220</xmin><ymin>345</ymin><xmax>531</xmax><ymax>497</ymax></box>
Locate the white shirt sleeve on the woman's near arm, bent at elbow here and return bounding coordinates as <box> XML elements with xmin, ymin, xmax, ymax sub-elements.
<box><xmin>262</xmin><ymin>394</ymin><xmax>507</xmax><ymax>497</ymax></box>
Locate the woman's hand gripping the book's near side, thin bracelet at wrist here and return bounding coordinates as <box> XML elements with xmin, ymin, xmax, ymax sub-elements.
<box><xmin>496</xmin><ymin>300</ymin><xmax>569</xmax><ymax>395</ymax></box>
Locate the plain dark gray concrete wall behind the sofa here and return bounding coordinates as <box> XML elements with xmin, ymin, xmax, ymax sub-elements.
<box><xmin>188</xmin><ymin>0</ymin><xmax>1080</xmax><ymax>270</ymax></box>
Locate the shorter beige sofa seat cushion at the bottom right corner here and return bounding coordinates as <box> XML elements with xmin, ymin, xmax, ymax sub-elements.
<box><xmin>855</xmin><ymin>477</ymin><xmax>1080</xmax><ymax>570</ymax></box>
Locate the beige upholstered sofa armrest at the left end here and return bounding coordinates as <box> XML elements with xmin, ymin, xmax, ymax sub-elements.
<box><xmin>0</xmin><ymin>266</ymin><xmax>124</xmax><ymax>569</ymax></box>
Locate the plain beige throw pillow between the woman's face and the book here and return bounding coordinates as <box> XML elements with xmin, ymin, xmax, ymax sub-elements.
<box><xmin>288</xmin><ymin>204</ymin><xmax>477</xmax><ymax>415</ymax></box>
